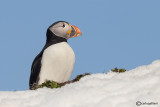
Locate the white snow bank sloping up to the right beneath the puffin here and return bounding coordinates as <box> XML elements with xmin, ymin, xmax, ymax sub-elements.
<box><xmin>0</xmin><ymin>60</ymin><xmax>160</xmax><ymax>107</ymax></box>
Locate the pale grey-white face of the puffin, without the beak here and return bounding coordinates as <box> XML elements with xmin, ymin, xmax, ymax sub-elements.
<box><xmin>49</xmin><ymin>22</ymin><xmax>71</xmax><ymax>39</ymax></box>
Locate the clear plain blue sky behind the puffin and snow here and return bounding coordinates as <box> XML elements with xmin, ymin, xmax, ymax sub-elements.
<box><xmin>0</xmin><ymin>0</ymin><xmax>160</xmax><ymax>91</ymax></box>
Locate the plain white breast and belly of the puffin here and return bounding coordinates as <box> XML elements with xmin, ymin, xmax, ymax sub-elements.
<box><xmin>38</xmin><ymin>42</ymin><xmax>75</xmax><ymax>84</ymax></box>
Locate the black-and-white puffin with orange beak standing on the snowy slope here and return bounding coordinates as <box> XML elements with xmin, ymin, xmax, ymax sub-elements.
<box><xmin>29</xmin><ymin>21</ymin><xmax>82</xmax><ymax>89</ymax></box>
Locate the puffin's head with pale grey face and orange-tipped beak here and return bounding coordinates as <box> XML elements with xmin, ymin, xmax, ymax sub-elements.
<box><xmin>48</xmin><ymin>21</ymin><xmax>81</xmax><ymax>39</ymax></box>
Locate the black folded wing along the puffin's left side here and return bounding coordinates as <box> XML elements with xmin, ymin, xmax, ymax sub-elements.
<box><xmin>29</xmin><ymin>51</ymin><xmax>43</xmax><ymax>89</ymax></box>
